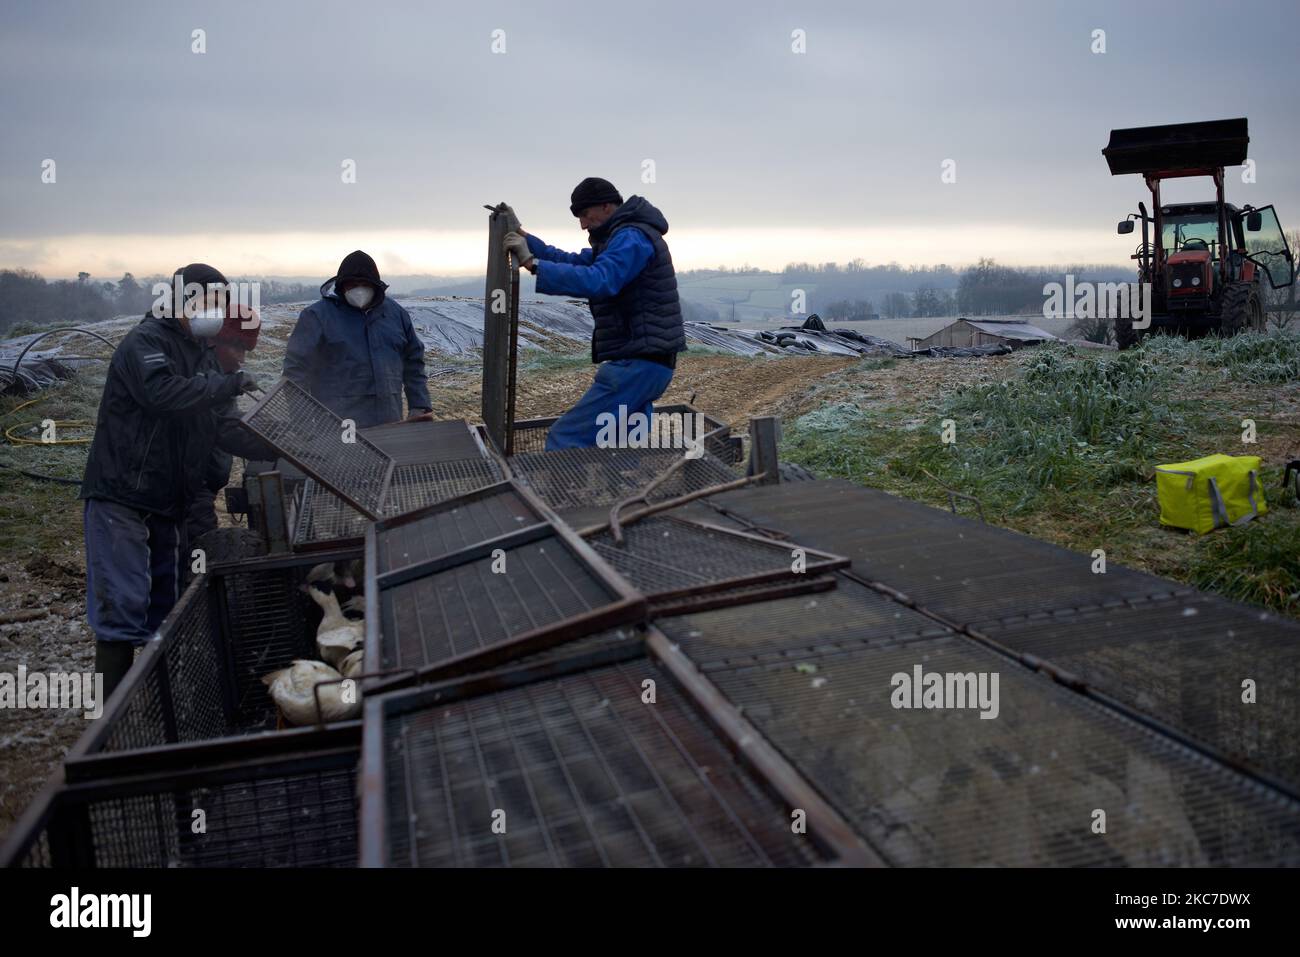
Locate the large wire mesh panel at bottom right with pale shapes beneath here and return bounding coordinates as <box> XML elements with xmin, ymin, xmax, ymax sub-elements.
<box><xmin>710</xmin><ymin>636</ymin><xmax>1300</xmax><ymax>866</ymax></box>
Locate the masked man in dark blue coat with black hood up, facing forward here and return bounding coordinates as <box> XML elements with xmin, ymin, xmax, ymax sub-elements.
<box><xmin>285</xmin><ymin>250</ymin><xmax>433</xmax><ymax>429</ymax></box>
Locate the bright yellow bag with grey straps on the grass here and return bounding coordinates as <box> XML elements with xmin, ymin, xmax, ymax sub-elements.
<box><xmin>1156</xmin><ymin>455</ymin><xmax>1269</xmax><ymax>534</ymax></box>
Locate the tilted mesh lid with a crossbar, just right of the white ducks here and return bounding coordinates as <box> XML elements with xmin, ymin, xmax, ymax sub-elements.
<box><xmin>365</xmin><ymin>481</ymin><xmax>646</xmax><ymax>688</ymax></box>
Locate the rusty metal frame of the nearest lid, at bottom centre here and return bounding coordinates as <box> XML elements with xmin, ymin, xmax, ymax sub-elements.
<box><xmin>358</xmin><ymin>625</ymin><xmax>885</xmax><ymax>867</ymax></box>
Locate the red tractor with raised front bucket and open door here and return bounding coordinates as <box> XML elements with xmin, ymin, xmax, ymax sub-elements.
<box><xmin>1101</xmin><ymin>117</ymin><xmax>1295</xmax><ymax>348</ymax></box>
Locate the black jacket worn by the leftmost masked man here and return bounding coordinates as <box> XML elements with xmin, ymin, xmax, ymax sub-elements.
<box><xmin>81</xmin><ymin>315</ymin><xmax>276</xmax><ymax>521</ymax></box>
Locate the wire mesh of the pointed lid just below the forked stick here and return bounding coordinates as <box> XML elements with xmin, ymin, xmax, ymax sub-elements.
<box><xmin>588</xmin><ymin>515</ymin><xmax>848</xmax><ymax>598</ymax></box>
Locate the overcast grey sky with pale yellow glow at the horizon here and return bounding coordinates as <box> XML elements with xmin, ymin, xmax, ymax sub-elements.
<box><xmin>0</xmin><ymin>0</ymin><xmax>1300</xmax><ymax>278</ymax></box>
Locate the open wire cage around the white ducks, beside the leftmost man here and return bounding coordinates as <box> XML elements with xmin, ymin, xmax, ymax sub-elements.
<box><xmin>65</xmin><ymin>551</ymin><xmax>360</xmax><ymax>779</ymax></box>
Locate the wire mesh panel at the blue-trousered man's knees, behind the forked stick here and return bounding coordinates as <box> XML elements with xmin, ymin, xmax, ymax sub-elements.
<box><xmin>510</xmin><ymin>449</ymin><xmax>736</xmax><ymax>514</ymax></box>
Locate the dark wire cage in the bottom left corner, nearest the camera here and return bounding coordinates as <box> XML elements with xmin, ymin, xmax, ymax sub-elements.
<box><xmin>0</xmin><ymin>722</ymin><xmax>360</xmax><ymax>869</ymax></box>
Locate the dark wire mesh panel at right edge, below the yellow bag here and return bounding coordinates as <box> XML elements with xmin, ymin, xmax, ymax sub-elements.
<box><xmin>982</xmin><ymin>596</ymin><xmax>1300</xmax><ymax>789</ymax></box>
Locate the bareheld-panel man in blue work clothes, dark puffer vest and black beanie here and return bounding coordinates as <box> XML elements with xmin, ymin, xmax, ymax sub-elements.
<box><xmin>501</xmin><ymin>177</ymin><xmax>686</xmax><ymax>451</ymax></box>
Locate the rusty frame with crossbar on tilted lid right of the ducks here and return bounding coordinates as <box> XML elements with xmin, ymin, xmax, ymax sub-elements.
<box><xmin>363</xmin><ymin>480</ymin><xmax>650</xmax><ymax>694</ymax></box>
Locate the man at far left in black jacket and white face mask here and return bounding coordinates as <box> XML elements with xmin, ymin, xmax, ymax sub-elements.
<box><xmin>81</xmin><ymin>263</ymin><xmax>274</xmax><ymax>696</ymax></box>
